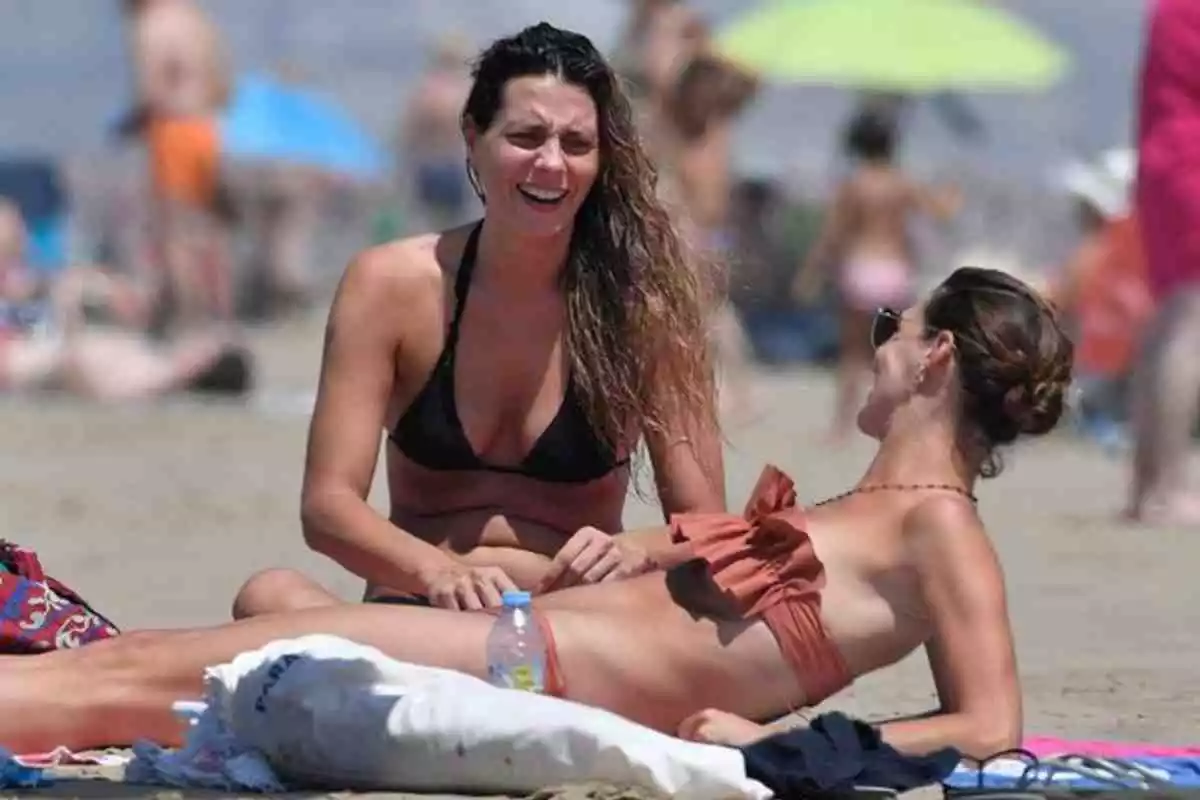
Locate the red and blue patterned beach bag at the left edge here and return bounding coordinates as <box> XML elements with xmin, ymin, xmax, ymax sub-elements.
<box><xmin>0</xmin><ymin>540</ymin><xmax>119</xmax><ymax>655</ymax></box>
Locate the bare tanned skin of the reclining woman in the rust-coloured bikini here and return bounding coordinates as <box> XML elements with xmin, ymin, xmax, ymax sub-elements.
<box><xmin>0</xmin><ymin>312</ymin><xmax>1021</xmax><ymax>757</ymax></box>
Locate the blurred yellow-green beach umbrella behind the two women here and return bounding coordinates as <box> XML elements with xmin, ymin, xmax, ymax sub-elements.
<box><xmin>718</xmin><ymin>0</ymin><xmax>1086</xmax><ymax>92</ymax></box>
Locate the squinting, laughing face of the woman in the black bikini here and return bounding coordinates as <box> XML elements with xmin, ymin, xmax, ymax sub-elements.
<box><xmin>463</xmin><ymin>74</ymin><xmax>600</xmax><ymax>237</ymax></box>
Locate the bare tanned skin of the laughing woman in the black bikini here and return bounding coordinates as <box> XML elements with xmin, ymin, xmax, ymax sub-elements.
<box><xmin>234</xmin><ymin>71</ymin><xmax>725</xmax><ymax>616</ymax></box>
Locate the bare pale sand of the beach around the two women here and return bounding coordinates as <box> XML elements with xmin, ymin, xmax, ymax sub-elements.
<box><xmin>0</xmin><ymin>314</ymin><xmax>1200</xmax><ymax>798</ymax></box>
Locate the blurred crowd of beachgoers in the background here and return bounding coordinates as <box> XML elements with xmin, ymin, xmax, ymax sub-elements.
<box><xmin>0</xmin><ymin>0</ymin><xmax>1200</xmax><ymax>516</ymax></box>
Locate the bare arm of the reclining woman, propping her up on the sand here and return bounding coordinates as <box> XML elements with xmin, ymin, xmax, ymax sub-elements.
<box><xmin>881</xmin><ymin>498</ymin><xmax>1022</xmax><ymax>758</ymax></box>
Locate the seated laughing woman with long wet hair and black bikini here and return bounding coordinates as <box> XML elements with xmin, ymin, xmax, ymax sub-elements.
<box><xmin>234</xmin><ymin>24</ymin><xmax>725</xmax><ymax>618</ymax></box>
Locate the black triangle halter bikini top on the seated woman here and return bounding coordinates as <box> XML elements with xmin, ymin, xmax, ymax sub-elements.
<box><xmin>388</xmin><ymin>225</ymin><xmax>629</xmax><ymax>483</ymax></box>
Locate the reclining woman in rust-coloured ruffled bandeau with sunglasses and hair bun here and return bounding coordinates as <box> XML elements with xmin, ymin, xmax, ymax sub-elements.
<box><xmin>0</xmin><ymin>269</ymin><xmax>1073</xmax><ymax>757</ymax></box>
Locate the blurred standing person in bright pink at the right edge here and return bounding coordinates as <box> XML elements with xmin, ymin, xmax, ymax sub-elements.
<box><xmin>1128</xmin><ymin>0</ymin><xmax>1200</xmax><ymax>523</ymax></box>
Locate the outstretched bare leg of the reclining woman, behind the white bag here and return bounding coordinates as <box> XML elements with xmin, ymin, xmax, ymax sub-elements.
<box><xmin>0</xmin><ymin>606</ymin><xmax>492</xmax><ymax>752</ymax></box>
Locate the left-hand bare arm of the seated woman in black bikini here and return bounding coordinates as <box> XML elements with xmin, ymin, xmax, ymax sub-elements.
<box><xmin>301</xmin><ymin>242</ymin><xmax>452</xmax><ymax>591</ymax></box>
